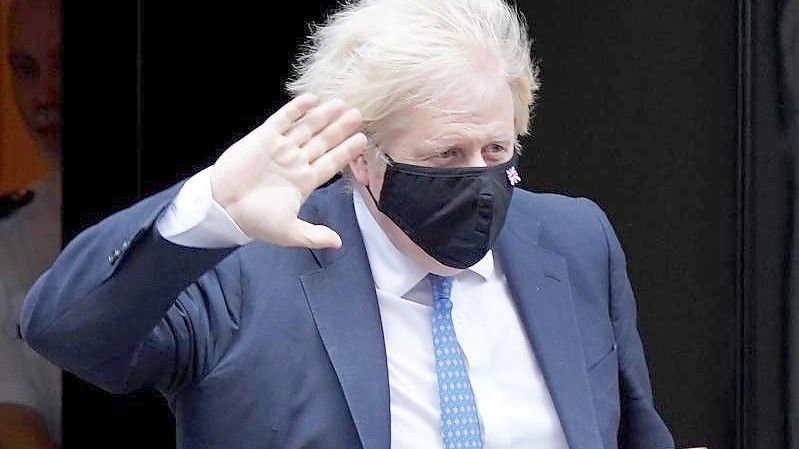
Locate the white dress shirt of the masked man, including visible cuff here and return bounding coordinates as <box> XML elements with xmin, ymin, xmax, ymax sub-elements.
<box><xmin>157</xmin><ymin>169</ymin><xmax>568</xmax><ymax>449</ymax></box>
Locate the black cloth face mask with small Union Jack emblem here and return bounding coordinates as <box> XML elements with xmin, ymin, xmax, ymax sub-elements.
<box><xmin>369</xmin><ymin>155</ymin><xmax>521</xmax><ymax>269</ymax></box>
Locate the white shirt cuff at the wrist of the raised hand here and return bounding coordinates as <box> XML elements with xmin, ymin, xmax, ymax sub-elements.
<box><xmin>155</xmin><ymin>166</ymin><xmax>252</xmax><ymax>248</ymax></box>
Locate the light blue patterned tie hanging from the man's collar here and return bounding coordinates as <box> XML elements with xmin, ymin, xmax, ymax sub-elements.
<box><xmin>427</xmin><ymin>274</ymin><xmax>483</xmax><ymax>449</ymax></box>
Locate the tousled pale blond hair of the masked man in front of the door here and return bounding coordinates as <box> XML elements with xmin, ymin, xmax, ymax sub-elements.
<box><xmin>286</xmin><ymin>0</ymin><xmax>539</xmax><ymax>150</ymax></box>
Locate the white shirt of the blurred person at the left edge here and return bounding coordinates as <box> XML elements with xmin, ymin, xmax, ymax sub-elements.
<box><xmin>0</xmin><ymin>158</ymin><xmax>61</xmax><ymax>442</ymax></box>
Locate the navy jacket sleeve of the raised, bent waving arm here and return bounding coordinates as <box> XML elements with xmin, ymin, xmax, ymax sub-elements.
<box><xmin>21</xmin><ymin>178</ymin><xmax>247</xmax><ymax>395</ymax></box>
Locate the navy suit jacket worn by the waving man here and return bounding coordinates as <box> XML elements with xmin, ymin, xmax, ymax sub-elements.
<box><xmin>22</xmin><ymin>177</ymin><xmax>674</xmax><ymax>449</ymax></box>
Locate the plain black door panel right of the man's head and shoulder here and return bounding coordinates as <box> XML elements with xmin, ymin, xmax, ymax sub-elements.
<box><xmin>524</xmin><ymin>0</ymin><xmax>737</xmax><ymax>448</ymax></box>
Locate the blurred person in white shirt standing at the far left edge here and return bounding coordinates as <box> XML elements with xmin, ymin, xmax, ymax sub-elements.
<box><xmin>0</xmin><ymin>0</ymin><xmax>62</xmax><ymax>449</ymax></box>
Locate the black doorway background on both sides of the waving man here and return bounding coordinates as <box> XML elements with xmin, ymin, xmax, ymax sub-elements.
<box><xmin>64</xmin><ymin>0</ymin><xmax>787</xmax><ymax>449</ymax></box>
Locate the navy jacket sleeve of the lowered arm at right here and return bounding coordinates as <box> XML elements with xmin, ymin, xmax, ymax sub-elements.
<box><xmin>591</xmin><ymin>202</ymin><xmax>674</xmax><ymax>449</ymax></box>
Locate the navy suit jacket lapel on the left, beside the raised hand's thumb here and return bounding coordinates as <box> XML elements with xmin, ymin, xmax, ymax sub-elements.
<box><xmin>300</xmin><ymin>182</ymin><xmax>391</xmax><ymax>449</ymax></box>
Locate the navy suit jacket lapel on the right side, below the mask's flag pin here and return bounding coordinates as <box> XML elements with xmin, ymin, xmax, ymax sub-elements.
<box><xmin>496</xmin><ymin>204</ymin><xmax>602</xmax><ymax>449</ymax></box>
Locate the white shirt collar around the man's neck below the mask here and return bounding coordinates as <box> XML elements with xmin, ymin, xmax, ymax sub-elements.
<box><xmin>353</xmin><ymin>190</ymin><xmax>495</xmax><ymax>297</ymax></box>
